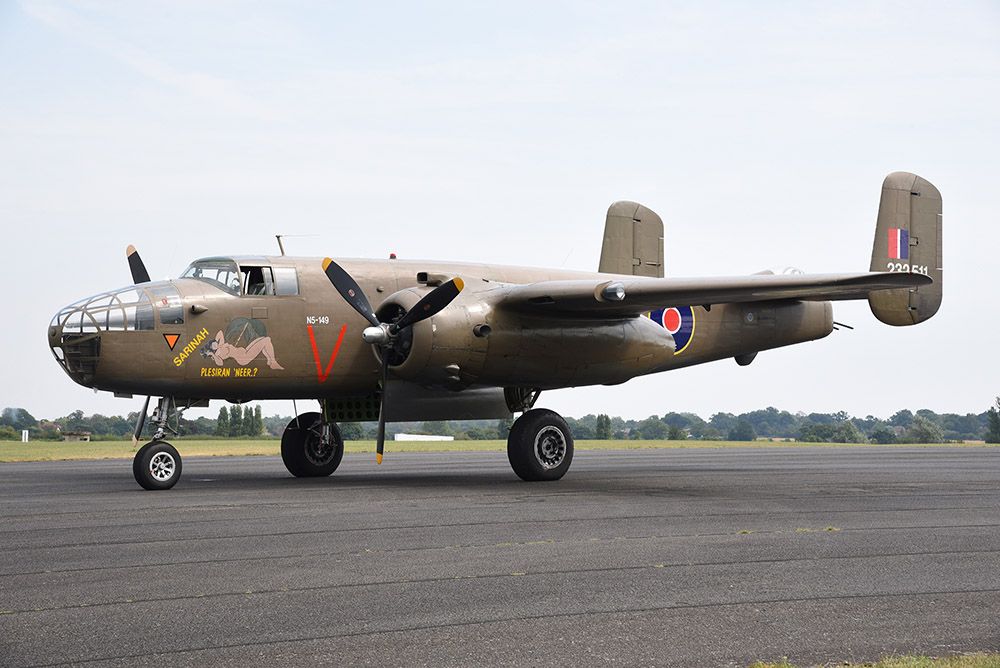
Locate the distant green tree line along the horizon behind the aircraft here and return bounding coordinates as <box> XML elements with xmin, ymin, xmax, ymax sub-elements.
<box><xmin>0</xmin><ymin>397</ymin><xmax>1000</xmax><ymax>443</ymax></box>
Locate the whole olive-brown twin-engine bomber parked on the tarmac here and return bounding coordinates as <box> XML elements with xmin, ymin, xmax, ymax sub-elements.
<box><xmin>48</xmin><ymin>172</ymin><xmax>942</xmax><ymax>489</ymax></box>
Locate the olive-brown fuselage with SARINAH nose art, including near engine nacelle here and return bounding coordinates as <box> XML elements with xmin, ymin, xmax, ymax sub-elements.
<box><xmin>48</xmin><ymin>256</ymin><xmax>833</xmax><ymax>402</ymax></box>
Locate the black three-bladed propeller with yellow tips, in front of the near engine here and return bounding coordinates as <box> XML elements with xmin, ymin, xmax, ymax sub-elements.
<box><xmin>323</xmin><ymin>258</ymin><xmax>465</xmax><ymax>464</ymax></box>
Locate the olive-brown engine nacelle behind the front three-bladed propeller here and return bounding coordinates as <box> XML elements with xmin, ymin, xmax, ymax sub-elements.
<box><xmin>377</xmin><ymin>284</ymin><xmax>675</xmax><ymax>390</ymax></box>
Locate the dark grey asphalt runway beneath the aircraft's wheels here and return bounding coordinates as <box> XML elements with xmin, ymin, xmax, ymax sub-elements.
<box><xmin>0</xmin><ymin>447</ymin><xmax>1000</xmax><ymax>666</ymax></box>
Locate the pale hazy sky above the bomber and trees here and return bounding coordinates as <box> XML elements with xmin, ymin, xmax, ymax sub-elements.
<box><xmin>0</xmin><ymin>1</ymin><xmax>1000</xmax><ymax>417</ymax></box>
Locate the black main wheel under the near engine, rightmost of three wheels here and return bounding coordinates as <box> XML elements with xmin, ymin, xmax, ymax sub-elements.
<box><xmin>507</xmin><ymin>408</ymin><xmax>573</xmax><ymax>481</ymax></box>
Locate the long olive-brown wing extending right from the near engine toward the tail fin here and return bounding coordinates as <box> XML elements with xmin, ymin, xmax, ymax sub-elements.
<box><xmin>497</xmin><ymin>272</ymin><xmax>933</xmax><ymax>316</ymax></box>
